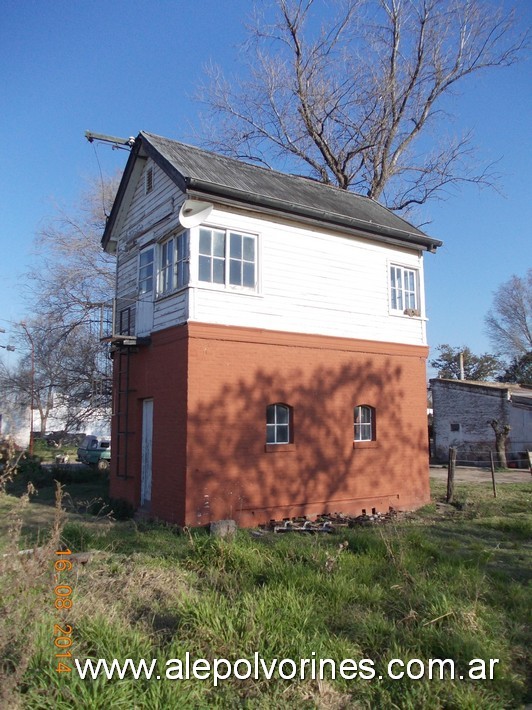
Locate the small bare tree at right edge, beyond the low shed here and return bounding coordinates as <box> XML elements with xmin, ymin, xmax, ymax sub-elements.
<box><xmin>486</xmin><ymin>269</ymin><xmax>532</xmax><ymax>359</ymax></box>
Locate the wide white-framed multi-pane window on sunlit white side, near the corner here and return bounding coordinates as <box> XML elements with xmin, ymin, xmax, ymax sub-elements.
<box><xmin>198</xmin><ymin>227</ymin><xmax>257</xmax><ymax>290</ymax></box>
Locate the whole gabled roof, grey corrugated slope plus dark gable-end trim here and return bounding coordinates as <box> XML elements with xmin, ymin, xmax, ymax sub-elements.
<box><xmin>102</xmin><ymin>131</ymin><xmax>442</xmax><ymax>251</ymax></box>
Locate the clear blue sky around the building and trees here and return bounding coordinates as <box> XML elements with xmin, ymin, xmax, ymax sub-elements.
<box><xmin>0</xmin><ymin>0</ymin><xmax>532</xmax><ymax>372</ymax></box>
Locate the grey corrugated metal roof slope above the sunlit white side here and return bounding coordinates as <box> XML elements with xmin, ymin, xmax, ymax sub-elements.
<box><xmin>139</xmin><ymin>131</ymin><xmax>441</xmax><ymax>249</ymax></box>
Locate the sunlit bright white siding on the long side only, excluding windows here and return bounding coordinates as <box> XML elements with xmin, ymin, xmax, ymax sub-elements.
<box><xmin>190</xmin><ymin>211</ymin><xmax>426</xmax><ymax>345</ymax></box>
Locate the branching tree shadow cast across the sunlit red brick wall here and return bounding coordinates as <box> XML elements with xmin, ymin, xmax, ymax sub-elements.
<box><xmin>187</xmin><ymin>356</ymin><xmax>428</xmax><ymax>524</ymax></box>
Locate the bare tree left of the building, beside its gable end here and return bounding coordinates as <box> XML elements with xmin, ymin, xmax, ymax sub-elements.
<box><xmin>0</xmin><ymin>178</ymin><xmax>118</xmax><ymax>433</ymax></box>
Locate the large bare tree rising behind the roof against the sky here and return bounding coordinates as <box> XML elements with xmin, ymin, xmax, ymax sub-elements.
<box><xmin>199</xmin><ymin>0</ymin><xmax>527</xmax><ymax>210</ymax></box>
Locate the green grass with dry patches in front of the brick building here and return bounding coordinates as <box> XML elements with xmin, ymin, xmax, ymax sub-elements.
<box><xmin>0</xmin><ymin>484</ymin><xmax>532</xmax><ymax>710</ymax></box>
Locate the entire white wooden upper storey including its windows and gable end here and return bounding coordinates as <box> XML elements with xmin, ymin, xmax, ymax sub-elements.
<box><xmin>107</xmin><ymin>133</ymin><xmax>439</xmax><ymax>345</ymax></box>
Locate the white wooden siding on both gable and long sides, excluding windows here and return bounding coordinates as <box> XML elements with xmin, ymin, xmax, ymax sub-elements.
<box><xmin>117</xmin><ymin>167</ymin><xmax>426</xmax><ymax>345</ymax></box>
